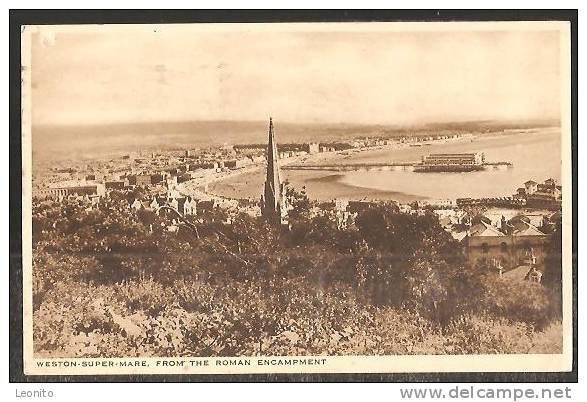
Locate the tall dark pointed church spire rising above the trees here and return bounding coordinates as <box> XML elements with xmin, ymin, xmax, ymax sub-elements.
<box><xmin>261</xmin><ymin>117</ymin><xmax>285</xmax><ymax>223</ymax></box>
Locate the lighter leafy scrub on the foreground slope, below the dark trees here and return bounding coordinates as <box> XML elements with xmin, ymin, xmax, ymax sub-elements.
<box><xmin>34</xmin><ymin>279</ymin><xmax>560</xmax><ymax>357</ymax></box>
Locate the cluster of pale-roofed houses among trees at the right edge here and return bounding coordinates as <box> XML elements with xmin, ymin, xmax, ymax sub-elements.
<box><xmin>435</xmin><ymin>179</ymin><xmax>562</xmax><ymax>280</ymax></box>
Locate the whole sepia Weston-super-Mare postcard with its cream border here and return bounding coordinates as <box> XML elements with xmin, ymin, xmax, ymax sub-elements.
<box><xmin>21</xmin><ymin>21</ymin><xmax>573</xmax><ymax>375</ymax></box>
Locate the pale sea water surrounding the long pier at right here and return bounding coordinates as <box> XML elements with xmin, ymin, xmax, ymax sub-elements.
<box><xmin>326</xmin><ymin>130</ymin><xmax>561</xmax><ymax>199</ymax></box>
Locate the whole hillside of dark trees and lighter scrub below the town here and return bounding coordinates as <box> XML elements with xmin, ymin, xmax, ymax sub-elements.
<box><xmin>33</xmin><ymin>194</ymin><xmax>561</xmax><ymax>357</ymax></box>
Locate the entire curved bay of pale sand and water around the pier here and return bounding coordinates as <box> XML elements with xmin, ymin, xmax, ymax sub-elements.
<box><xmin>195</xmin><ymin>129</ymin><xmax>560</xmax><ymax>202</ymax></box>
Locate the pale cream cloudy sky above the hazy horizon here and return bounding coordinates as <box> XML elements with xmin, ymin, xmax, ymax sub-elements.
<box><xmin>32</xmin><ymin>24</ymin><xmax>561</xmax><ymax>125</ymax></box>
